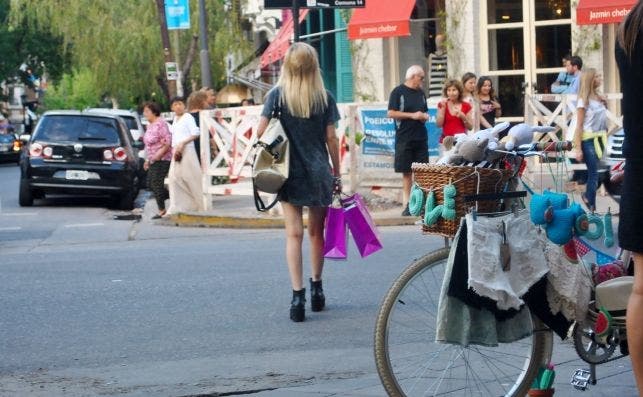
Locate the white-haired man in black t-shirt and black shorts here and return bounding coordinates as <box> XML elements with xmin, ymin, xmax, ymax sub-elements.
<box><xmin>388</xmin><ymin>65</ymin><xmax>429</xmax><ymax>216</ymax></box>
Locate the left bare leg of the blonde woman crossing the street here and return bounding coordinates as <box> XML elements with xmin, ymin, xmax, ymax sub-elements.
<box><xmin>281</xmin><ymin>201</ymin><xmax>304</xmax><ymax>291</ymax></box>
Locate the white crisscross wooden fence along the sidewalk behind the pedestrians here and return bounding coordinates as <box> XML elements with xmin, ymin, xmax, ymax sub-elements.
<box><xmin>194</xmin><ymin>94</ymin><xmax>623</xmax><ymax>209</ymax></box>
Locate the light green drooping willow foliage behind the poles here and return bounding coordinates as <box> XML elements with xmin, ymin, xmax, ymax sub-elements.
<box><xmin>9</xmin><ymin>0</ymin><xmax>249</xmax><ymax>106</ymax></box>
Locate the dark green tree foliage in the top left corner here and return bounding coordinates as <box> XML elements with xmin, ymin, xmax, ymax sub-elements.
<box><xmin>0</xmin><ymin>0</ymin><xmax>70</xmax><ymax>88</ymax></box>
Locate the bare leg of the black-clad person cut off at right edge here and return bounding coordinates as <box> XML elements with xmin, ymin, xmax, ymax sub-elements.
<box><xmin>627</xmin><ymin>253</ymin><xmax>643</xmax><ymax>396</ymax></box>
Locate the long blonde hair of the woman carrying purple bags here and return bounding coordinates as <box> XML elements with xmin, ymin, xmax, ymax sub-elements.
<box><xmin>277</xmin><ymin>43</ymin><xmax>328</xmax><ymax>118</ymax></box>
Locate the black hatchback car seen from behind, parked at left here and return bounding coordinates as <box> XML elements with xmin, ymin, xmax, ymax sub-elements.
<box><xmin>19</xmin><ymin>111</ymin><xmax>142</xmax><ymax>210</ymax></box>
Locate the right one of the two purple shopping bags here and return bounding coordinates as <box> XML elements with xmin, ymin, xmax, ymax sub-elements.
<box><xmin>342</xmin><ymin>193</ymin><xmax>382</xmax><ymax>258</ymax></box>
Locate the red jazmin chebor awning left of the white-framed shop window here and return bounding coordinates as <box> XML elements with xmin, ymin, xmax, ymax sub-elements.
<box><xmin>348</xmin><ymin>0</ymin><xmax>415</xmax><ymax>40</ymax></box>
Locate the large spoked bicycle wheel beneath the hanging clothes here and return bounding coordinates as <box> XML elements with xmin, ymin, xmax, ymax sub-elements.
<box><xmin>375</xmin><ymin>248</ymin><xmax>553</xmax><ymax>397</ymax></box>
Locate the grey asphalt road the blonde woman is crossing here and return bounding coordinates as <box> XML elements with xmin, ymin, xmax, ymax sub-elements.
<box><xmin>0</xmin><ymin>164</ymin><xmax>635</xmax><ymax>396</ymax></box>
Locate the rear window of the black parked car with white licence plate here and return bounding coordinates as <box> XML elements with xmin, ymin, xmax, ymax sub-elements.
<box><xmin>34</xmin><ymin>116</ymin><xmax>120</xmax><ymax>145</ymax></box>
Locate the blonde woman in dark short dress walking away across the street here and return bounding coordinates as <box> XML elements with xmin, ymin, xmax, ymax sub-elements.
<box><xmin>258</xmin><ymin>43</ymin><xmax>341</xmax><ymax>322</ymax></box>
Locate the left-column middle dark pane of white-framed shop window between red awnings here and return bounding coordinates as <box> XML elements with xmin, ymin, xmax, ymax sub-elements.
<box><xmin>489</xmin><ymin>28</ymin><xmax>525</xmax><ymax>70</ymax></box>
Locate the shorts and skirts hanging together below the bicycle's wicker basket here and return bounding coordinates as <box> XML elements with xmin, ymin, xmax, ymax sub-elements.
<box><xmin>436</xmin><ymin>211</ymin><xmax>580</xmax><ymax>346</ymax></box>
